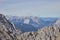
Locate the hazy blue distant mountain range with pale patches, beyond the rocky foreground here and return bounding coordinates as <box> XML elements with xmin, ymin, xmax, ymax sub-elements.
<box><xmin>6</xmin><ymin>16</ymin><xmax>58</xmax><ymax>32</ymax></box>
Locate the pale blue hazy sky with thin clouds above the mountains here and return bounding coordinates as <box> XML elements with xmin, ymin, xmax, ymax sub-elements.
<box><xmin>0</xmin><ymin>0</ymin><xmax>60</xmax><ymax>17</ymax></box>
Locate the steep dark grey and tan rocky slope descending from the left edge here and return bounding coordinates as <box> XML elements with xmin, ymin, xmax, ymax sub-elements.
<box><xmin>0</xmin><ymin>14</ymin><xmax>20</xmax><ymax>40</ymax></box>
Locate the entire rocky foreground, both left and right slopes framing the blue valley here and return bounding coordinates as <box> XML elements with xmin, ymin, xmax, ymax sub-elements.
<box><xmin>0</xmin><ymin>14</ymin><xmax>60</xmax><ymax>40</ymax></box>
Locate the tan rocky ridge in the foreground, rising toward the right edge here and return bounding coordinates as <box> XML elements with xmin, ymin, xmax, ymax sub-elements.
<box><xmin>21</xmin><ymin>20</ymin><xmax>60</xmax><ymax>40</ymax></box>
